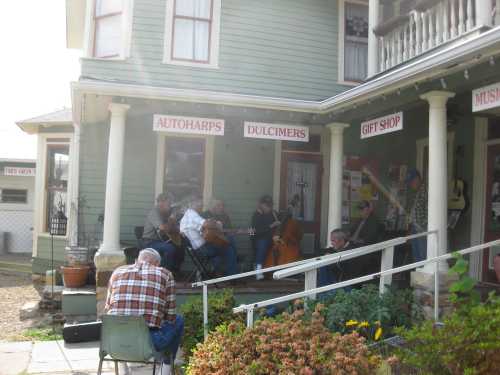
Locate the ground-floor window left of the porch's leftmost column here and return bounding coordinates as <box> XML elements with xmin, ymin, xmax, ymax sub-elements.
<box><xmin>44</xmin><ymin>145</ymin><xmax>69</xmax><ymax>232</ymax></box>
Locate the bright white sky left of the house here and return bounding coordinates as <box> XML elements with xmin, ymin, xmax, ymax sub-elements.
<box><xmin>0</xmin><ymin>0</ymin><xmax>79</xmax><ymax>159</ymax></box>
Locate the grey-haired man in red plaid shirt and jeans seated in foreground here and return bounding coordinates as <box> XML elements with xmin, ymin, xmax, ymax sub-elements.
<box><xmin>105</xmin><ymin>249</ymin><xmax>184</xmax><ymax>374</ymax></box>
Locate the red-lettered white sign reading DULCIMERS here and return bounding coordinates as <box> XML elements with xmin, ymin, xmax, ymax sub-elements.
<box><xmin>243</xmin><ymin>121</ymin><xmax>309</xmax><ymax>142</ymax></box>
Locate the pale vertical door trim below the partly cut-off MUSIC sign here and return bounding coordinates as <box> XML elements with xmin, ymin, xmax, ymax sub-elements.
<box><xmin>469</xmin><ymin>117</ymin><xmax>488</xmax><ymax>280</ymax></box>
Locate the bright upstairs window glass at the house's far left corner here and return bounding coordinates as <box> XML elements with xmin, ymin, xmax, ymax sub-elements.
<box><xmin>93</xmin><ymin>0</ymin><xmax>124</xmax><ymax>58</ymax></box>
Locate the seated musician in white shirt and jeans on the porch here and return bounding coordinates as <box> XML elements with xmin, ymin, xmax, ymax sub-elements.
<box><xmin>180</xmin><ymin>197</ymin><xmax>238</xmax><ymax>276</ymax></box>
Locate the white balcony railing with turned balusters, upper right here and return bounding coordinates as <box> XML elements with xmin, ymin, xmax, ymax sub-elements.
<box><xmin>374</xmin><ymin>0</ymin><xmax>500</xmax><ymax>72</ymax></box>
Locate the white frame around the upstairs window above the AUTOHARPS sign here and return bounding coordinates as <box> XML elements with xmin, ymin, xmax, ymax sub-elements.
<box><xmin>163</xmin><ymin>0</ymin><xmax>221</xmax><ymax>69</ymax></box>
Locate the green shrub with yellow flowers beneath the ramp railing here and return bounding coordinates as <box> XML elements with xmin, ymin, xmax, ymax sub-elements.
<box><xmin>306</xmin><ymin>285</ymin><xmax>423</xmax><ymax>341</ymax></box>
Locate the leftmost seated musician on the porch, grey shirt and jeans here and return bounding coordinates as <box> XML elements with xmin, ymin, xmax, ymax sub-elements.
<box><xmin>142</xmin><ymin>193</ymin><xmax>184</xmax><ymax>272</ymax></box>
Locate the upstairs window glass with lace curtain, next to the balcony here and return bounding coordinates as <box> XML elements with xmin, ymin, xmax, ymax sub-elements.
<box><xmin>342</xmin><ymin>1</ymin><xmax>368</xmax><ymax>82</ymax></box>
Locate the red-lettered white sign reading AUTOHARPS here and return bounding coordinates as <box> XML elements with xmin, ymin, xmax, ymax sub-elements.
<box><xmin>153</xmin><ymin>115</ymin><xmax>224</xmax><ymax>135</ymax></box>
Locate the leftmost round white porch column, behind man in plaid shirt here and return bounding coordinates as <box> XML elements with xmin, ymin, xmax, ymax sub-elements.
<box><xmin>99</xmin><ymin>103</ymin><xmax>130</xmax><ymax>253</ymax></box>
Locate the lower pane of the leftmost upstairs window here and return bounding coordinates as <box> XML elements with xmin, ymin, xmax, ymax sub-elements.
<box><xmin>95</xmin><ymin>15</ymin><xmax>122</xmax><ymax>57</ymax></box>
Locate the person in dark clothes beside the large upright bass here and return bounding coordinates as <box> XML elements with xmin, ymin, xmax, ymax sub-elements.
<box><xmin>252</xmin><ymin>195</ymin><xmax>281</xmax><ymax>280</ymax></box>
